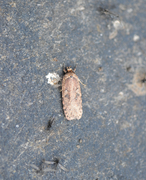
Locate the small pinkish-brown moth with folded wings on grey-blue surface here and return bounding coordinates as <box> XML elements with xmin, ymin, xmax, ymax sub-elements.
<box><xmin>62</xmin><ymin>67</ymin><xmax>83</xmax><ymax>120</ymax></box>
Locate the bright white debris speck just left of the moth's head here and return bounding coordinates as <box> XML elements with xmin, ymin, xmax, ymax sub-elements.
<box><xmin>46</xmin><ymin>73</ymin><xmax>61</xmax><ymax>86</ymax></box>
